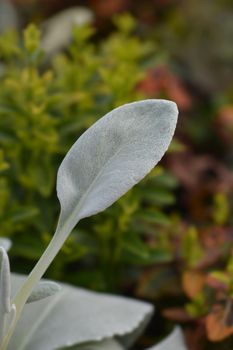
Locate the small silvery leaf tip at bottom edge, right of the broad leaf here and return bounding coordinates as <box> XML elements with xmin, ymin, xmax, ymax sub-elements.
<box><xmin>147</xmin><ymin>327</ymin><xmax>188</xmax><ymax>350</ymax></box>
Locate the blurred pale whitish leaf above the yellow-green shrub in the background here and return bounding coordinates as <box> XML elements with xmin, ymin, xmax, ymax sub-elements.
<box><xmin>41</xmin><ymin>6</ymin><xmax>94</xmax><ymax>56</ymax></box>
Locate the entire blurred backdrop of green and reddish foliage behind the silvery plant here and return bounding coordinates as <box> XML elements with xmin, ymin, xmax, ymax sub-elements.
<box><xmin>0</xmin><ymin>0</ymin><xmax>233</xmax><ymax>350</ymax></box>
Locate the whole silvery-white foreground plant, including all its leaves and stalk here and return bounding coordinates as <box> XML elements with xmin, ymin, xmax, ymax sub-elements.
<box><xmin>0</xmin><ymin>100</ymin><xmax>185</xmax><ymax>350</ymax></box>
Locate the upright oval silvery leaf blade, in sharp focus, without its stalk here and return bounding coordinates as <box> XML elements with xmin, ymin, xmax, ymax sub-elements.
<box><xmin>57</xmin><ymin>100</ymin><xmax>178</xmax><ymax>234</ymax></box>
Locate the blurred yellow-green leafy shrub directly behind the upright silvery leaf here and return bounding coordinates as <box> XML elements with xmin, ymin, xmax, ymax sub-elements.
<box><xmin>0</xmin><ymin>15</ymin><xmax>177</xmax><ymax>290</ymax></box>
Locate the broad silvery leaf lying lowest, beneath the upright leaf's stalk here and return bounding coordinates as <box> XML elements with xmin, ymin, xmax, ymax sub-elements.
<box><xmin>8</xmin><ymin>275</ymin><xmax>153</xmax><ymax>350</ymax></box>
